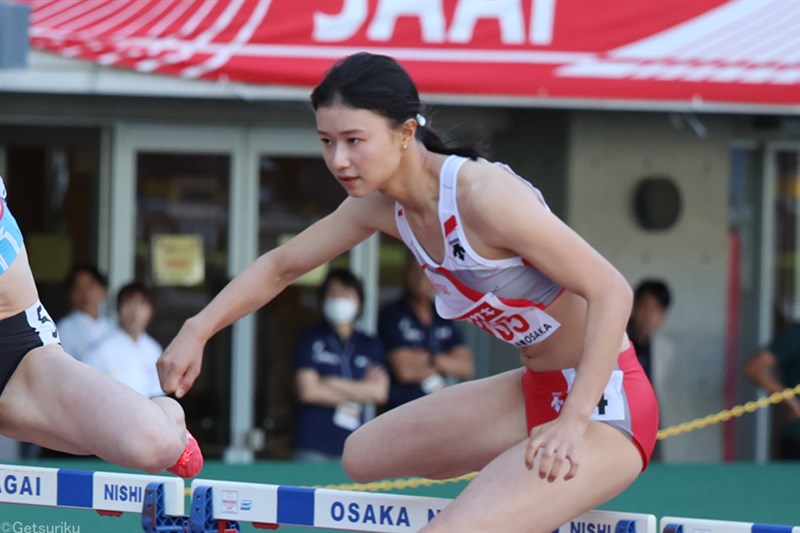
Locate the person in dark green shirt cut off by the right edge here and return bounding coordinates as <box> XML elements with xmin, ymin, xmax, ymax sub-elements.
<box><xmin>744</xmin><ymin>322</ymin><xmax>800</xmax><ymax>460</ymax></box>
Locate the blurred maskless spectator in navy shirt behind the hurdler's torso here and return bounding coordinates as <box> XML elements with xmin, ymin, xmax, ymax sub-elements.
<box><xmin>378</xmin><ymin>257</ymin><xmax>475</xmax><ymax>409</ymax></box>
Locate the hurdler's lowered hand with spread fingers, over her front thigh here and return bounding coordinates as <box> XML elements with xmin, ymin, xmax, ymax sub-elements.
<box><xmin>525</xmin><ymin>412</ymin><xmax>588</xmax><ymax>483</ymax></box>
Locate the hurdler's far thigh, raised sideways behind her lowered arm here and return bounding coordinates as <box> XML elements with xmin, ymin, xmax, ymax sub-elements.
<box><xmin>345</xmin><ymin>369</ymin><xmax>526</xmax><ymax>480</ymax></box>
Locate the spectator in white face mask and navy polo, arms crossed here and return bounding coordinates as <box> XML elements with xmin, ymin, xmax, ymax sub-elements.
<box><xmin>292</xmin><ymin>269</ymin><xmax>389</xmax><ymax>461</ymax></box>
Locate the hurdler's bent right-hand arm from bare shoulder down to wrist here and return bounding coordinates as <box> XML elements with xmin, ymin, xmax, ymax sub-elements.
<box><xmin>458</xmin><ymin>164</ymin><xmax>633</xmax><ymax>472</ymax></box>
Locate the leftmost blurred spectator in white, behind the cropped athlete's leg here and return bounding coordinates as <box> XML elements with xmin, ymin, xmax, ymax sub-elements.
<box><xmin>56</xmin><ymin>264</ymin><xmax>114</xmax><ymax>361</ymax></box>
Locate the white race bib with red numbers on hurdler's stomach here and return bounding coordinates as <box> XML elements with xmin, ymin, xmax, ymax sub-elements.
<box><xmin>456</xmin><ymin>293</ymin><xmax>561</xmax><ymax>348</ymax></box>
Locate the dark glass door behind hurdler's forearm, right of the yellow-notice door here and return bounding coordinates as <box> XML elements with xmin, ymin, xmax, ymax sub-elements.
<box><xmin>251</xmin><ymin>128</ymin><xmax>350</xmax><ymax>459</ymax></box>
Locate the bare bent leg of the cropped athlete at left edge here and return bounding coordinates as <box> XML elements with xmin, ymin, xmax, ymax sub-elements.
<box><xmin>0</xmin><ymin>346</ymin><xmax>186</xmax><ymax>473</ymax></box>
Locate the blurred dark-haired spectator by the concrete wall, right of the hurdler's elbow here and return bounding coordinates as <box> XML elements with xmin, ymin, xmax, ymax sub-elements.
<box><xmin>627</xmin><ymin>279</ymin><xmax>672</xmax><ymax>382</ymax></box>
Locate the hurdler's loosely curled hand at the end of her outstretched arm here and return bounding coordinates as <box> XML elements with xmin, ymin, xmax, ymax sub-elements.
<box><xmin>156</xmin><ymin>324</ymin><xmax>205</xmax><ymax>398</ymax></box>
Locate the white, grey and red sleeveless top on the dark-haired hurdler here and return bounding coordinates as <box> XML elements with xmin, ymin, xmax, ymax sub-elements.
<box><xmin>395</xmin><ymin>156</ymin><xmax>562</xmax><ymax>348</ymax></box>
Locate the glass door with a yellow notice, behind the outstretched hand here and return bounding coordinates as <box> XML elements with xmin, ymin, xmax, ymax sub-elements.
<box><xmin>110</xmin><ymin>124</ymin><xmax>247</xmax><ymax>458</ymax></box>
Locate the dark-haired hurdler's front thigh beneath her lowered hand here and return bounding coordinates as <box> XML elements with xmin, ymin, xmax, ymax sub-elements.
<box><xmin>424</xmin><ymin>422</ymin><xmax>642</xmax><ymax>533</ymax></box>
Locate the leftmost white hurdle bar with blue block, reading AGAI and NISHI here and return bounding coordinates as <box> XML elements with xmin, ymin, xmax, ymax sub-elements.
<box><xmin>0</xmin><ymin>464</ymin><xmax>186</xmax><ymax>516</ymax></box>
